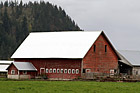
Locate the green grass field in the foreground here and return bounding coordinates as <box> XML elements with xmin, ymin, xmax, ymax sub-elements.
<box><xmin>0</xmin><ymin>80</ymin><xmax>140</xmax><ymax>93</ymax></box>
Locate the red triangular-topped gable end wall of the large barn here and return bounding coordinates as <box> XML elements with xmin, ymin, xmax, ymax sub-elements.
<box><xmin>83</xmin><ymin>34</ymin><xmax>118</xmax><ymax>73</ymax></box>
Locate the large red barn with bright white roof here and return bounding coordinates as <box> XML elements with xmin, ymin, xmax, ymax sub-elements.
<box><xmin>8</xmin><ymin>31</ymin><xmax>119</xmax><ymax>79</ymax></box>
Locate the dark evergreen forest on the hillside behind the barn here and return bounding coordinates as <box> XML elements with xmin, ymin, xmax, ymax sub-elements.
<box><xmin>0</xmin><ymin>0</ymin><xmax>81</xmax><ymax>60</ymax></box>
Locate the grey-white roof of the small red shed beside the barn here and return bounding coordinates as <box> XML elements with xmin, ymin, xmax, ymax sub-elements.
<box><xmin>13</xmin><ymin>62</ymin><xmax>37</xmax><ymax>71</ymax></box>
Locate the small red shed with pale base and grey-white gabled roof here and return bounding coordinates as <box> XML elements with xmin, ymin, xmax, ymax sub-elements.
<box><xmin>7</xmin><ymin>62</ymin><xmax>37</xmax><ymax>79</ymax></box>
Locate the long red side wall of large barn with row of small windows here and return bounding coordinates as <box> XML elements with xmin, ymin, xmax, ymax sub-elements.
<box><xmin>15</xmin><ymin>59</ymin><xmax>82</xmax><ymax>79</ymax></box>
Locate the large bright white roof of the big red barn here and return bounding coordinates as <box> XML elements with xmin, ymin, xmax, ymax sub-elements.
<box><xmin>11</xmin><ymin>31</ymin><xmax>102</xmax><ymax>58</ymax></box>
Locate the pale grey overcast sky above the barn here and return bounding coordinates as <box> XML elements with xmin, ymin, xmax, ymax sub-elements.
<box><xmin>0</xmin><ymin>0</ymin><xmax>140</xmax><ymax>51</ymax></box>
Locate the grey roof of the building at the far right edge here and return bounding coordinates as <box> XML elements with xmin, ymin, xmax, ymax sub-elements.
<box><xmin>118</xmin><ymin>50</ymin><xmax>140</xmax><ymax>66</ymax></box>
